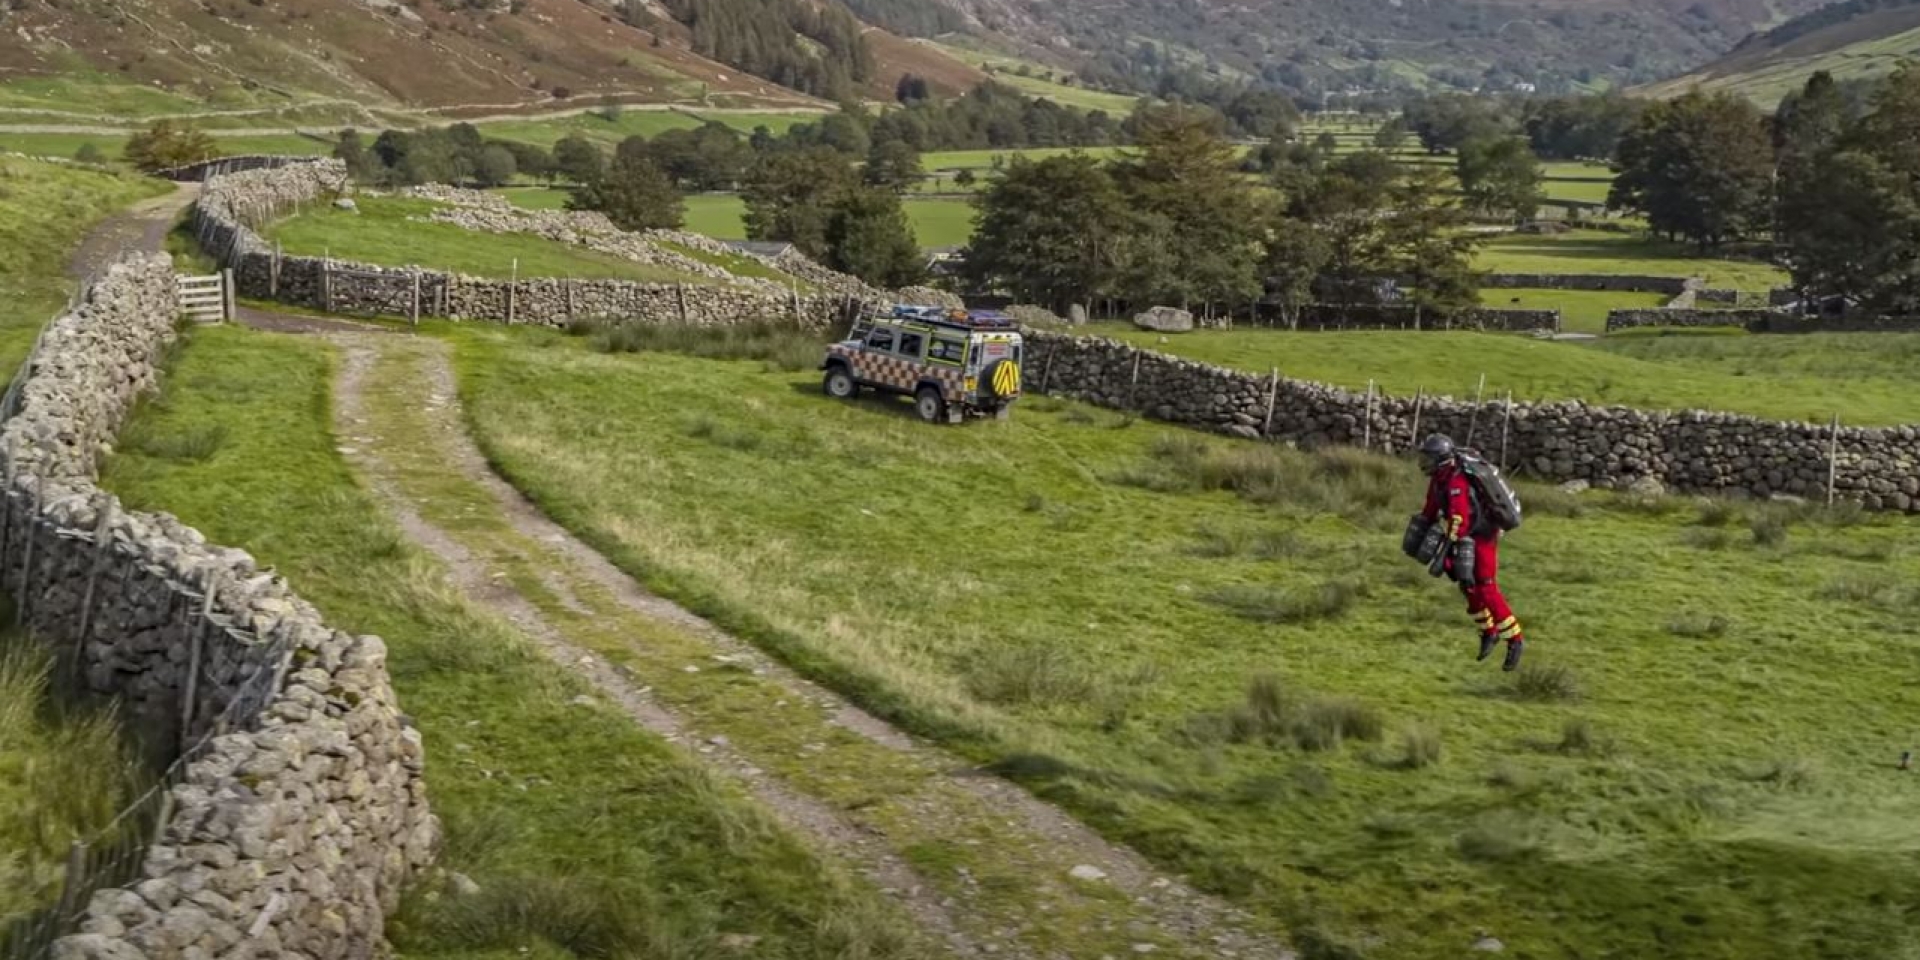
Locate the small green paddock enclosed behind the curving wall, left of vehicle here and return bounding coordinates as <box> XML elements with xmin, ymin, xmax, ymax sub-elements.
<box><xmin>267</xmin><ymin>196</ymin><xmax>707</xmax><ymax>284</ymax></box>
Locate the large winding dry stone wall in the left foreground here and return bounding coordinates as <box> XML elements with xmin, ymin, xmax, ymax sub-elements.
<box><xmin>0</xmin><ymin>257</ymin><xmax>438</xmax><ymax>960</ymax></box>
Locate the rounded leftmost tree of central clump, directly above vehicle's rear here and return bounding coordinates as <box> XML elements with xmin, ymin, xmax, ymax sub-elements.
<box><xmin>964</xmin><ymin>154</ymin><xmax>1131</xmax><ymax>311</ymax></box>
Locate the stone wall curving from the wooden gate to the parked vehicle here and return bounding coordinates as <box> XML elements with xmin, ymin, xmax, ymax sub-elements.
<box><xmin>194</xmin><ymin>159</ymin><xmax>877</xmax><ymax>328</ymax></box>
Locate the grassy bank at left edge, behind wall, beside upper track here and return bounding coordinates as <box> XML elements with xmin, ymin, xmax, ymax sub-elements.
<box><xmin>0</xmin><ymin>159</ymin><xmax>169</xmax><ymax>368</ymax></box>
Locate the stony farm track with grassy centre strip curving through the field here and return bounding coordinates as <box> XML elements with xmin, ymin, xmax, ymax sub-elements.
<box><xmin>328</xmin><ymin>332</ymin><xmax>1294</xmax><ymax>960</ymax></box>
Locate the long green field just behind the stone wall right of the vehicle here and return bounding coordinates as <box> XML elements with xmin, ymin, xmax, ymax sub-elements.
<box><xmin>1096</xmin><ymin>324</ymin><xmax>1920</xmax><ymax>426</ymax></box>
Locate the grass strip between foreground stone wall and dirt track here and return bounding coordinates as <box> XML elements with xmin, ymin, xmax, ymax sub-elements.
<box><xmin>105</xmin><ymin>326</ymin><xmax>925</xmax><ymax>960</ymax></box>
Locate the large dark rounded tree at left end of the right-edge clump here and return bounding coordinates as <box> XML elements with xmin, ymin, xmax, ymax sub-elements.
<box><xmin>1607</xmin><ymin>90</ymin><xmax>1774</xmax><ymax>250</ymax></box>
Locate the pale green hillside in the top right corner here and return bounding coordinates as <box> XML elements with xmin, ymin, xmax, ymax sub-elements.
<box><xmin>1644</xmin><ymin>0</ymin><xmax>1920</xmax><ymax>106</ymax></box>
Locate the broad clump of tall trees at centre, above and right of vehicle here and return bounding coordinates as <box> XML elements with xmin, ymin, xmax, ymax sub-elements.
<box><xmin>966</xmin><ymin>111</ymin><xmax>1478</xmax><ymax>321</ymax></box>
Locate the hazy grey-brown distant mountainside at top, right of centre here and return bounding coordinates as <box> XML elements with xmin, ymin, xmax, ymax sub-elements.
<box><xmin>936</xmin><ymin>0</ymin><xmax>1826</xmax><ymax>94</ymax></box>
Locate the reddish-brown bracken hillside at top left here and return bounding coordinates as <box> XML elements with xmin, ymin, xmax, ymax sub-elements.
<box><xmin>0</xmin><ymin>0</ymin><xmax>983</xmax><ymax>113</ymax></box>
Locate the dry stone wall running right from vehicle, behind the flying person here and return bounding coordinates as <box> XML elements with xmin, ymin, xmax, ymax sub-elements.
<box><xmin>1027</xmin><ymin>332</ymin><xmax>1920</xmax><ymax>513</ymax></box>
